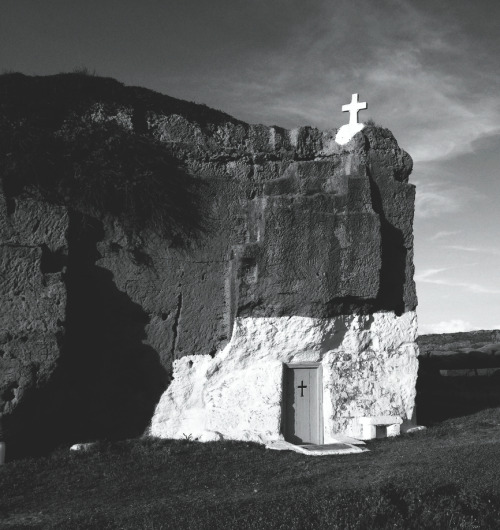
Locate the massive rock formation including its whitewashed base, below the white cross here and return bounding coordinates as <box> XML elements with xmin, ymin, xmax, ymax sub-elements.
<box><xmin>0</xmin><ymin>72</ymin><xmax>417</xmax><ymax>448</ymax></box>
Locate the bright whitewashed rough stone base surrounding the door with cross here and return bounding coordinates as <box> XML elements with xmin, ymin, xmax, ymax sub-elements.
<box><xmin>150</xmin><ymin>311</ymin><xmax>418</xmax><ymax>444</ymax></box>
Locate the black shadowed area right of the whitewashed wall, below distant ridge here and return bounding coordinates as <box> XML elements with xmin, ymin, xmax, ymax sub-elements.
<box><xmin>416</xmin><ymin>360</ymin><xmax>500</xmax><ymax>425</ymax></box>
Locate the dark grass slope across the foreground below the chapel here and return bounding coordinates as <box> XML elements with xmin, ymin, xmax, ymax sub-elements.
<box><xmin>0</xmin><ymin>409</ymin><xmax>500</xmax><ymax>529</ymax></box>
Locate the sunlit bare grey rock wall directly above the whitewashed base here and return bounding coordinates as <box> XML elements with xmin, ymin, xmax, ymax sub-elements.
<box><xmin>87</xmin><ymin>108</ymin><xmax>416</xmax><ymax>366</ymax></box>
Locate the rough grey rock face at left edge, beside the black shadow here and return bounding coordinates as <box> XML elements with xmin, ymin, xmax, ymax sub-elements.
<box><xmin>0</xmin><ymin>195</ymin><xmax>68</xmax><ymax>444</ymax></box>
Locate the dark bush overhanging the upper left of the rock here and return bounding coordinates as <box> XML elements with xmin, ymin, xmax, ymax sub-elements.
<box><xmin>0</xmin><ymin>73</ymin><xmax>207</xmax><ymax>241</ymax></box>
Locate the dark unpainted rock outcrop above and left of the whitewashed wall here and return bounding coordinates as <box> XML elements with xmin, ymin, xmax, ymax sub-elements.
<box><xmin>0</xmin><ymin>72</ymin><xmax>417</xmax><ymax>448</ymax></box>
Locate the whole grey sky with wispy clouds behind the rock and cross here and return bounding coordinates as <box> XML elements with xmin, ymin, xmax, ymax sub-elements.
<box><xmin>0</xmin><ymin>0</ymin><xmax>500</xmax><ymax>334</ymax></box>
